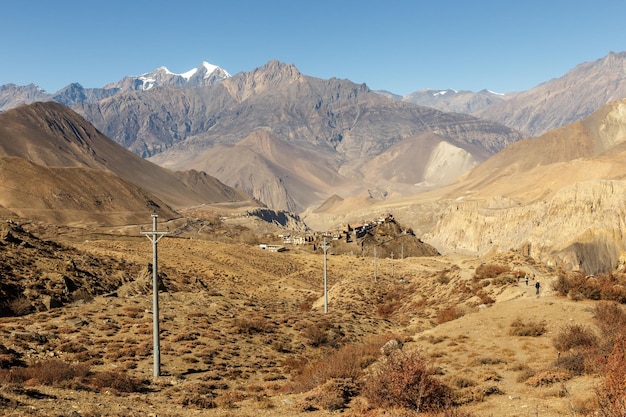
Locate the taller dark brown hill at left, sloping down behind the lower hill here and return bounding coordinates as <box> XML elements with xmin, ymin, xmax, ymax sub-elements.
<box><xmin>0</xmin><ymin>102</ymin><xmax>250</xmax><ymax>214</ymax></box>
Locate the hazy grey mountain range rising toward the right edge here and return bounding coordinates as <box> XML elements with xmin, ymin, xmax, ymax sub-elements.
<box><xmin>400</xmin><ymin>52</ymin><xmax>626</xmax><ymax>136</ymax></box>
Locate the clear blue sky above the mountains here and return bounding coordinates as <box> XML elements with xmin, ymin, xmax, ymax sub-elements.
<box><xmin>0</xmin><ymin>0</ymin><xmax>626</xmax><ymax>94</ymax></box>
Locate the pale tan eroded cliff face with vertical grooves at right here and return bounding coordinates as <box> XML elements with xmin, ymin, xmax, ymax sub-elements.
<box><xmin>424</xmin><ymin>180</ymin><xmax>626</xmax><ymax>274</ymax></box>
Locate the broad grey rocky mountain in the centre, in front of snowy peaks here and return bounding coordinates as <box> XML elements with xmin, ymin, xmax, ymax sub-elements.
<box><xmin>75</xmin><ymin>61</ymin><xmax>520</xmax><ymax>212</ymax></box>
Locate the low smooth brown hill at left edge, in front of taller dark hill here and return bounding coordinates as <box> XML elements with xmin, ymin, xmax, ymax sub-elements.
<box><xmin>0</xmin><ymin>157</ymin><xmax>180</xmax><ymax>226</ymax></box>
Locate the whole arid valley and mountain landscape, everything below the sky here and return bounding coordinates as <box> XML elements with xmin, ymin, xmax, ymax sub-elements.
<box><xmin>0</xmin><ymin>52</ymin><xmax>626</xmax><ymax>417</ymax></box>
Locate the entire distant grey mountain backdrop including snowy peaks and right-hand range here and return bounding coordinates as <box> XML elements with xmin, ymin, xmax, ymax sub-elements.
<box><xmin>1</xmin><ymin>53</ymin><xmax>626</xmax><ymax>211</ymax></box>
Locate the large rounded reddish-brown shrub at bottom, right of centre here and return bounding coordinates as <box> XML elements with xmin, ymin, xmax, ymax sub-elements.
<box><xmin>362</xmin><ymin>351</ymin><xmax>452</xmax><ymax>412</ymax></box>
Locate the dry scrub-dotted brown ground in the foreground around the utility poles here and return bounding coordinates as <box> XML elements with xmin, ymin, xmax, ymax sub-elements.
<box><xmin>0</xmin><ymin>218</ymin><xmax>616</xmax><ymax>417</ymax></box>
